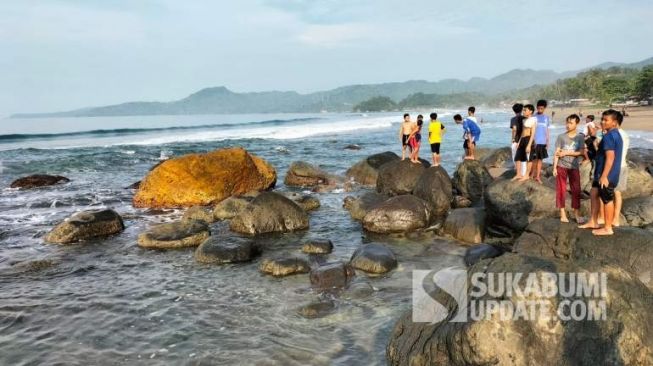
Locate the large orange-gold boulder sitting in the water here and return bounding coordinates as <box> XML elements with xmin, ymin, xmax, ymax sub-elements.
<box><xmin>133</xmin><ymin>148</ymin><xmax>277</xmax><ymax>208</ymax></box>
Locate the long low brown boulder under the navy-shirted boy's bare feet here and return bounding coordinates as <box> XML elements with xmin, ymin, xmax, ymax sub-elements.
<box><xmin>513</xmin><ymin>219</ymin><xmax>653</xmax><ymax>289</ymax></box>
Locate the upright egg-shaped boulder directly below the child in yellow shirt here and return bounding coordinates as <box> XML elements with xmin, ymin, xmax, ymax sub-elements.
<box><xmin>413</xmin><ymin>166</ymin><xmax>453</xmax><ymax>216</ymax></box>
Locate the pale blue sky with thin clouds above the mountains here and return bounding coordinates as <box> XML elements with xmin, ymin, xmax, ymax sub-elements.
<box><xmin>0</xmin><ymin>0</ymin><xmax>653</xmax><ymax>116</ymax></box>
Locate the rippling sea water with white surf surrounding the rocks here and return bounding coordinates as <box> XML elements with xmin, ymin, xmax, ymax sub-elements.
<box><xmin>0</xmin><ymin>111</ymin><xmax>653</xmax><ymax>365</ymax></box>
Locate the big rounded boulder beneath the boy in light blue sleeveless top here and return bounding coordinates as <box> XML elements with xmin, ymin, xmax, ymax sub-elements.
<box><xmin>485</xmin><ymin>179</ymin><xmax>559</xmax><ymax>236</ymax></box>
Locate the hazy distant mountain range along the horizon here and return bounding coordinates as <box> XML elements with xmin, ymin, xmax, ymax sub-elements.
<box><xmin>11</xmin><ymin>57</ymin><xmax>653</xmax><ymax>118</ymax></box>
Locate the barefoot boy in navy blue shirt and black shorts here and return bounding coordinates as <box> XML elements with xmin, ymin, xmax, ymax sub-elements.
<box><xmin>579</xmin><ymin>109</ymin><xmax>623</xmax><ymax>235</ymax></box>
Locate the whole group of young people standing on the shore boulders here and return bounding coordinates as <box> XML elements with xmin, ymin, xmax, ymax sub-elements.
<box><xmin>399</xmin><ymin>100</ymin><xmax>629</xmax><ymax>235</ymax></box>
